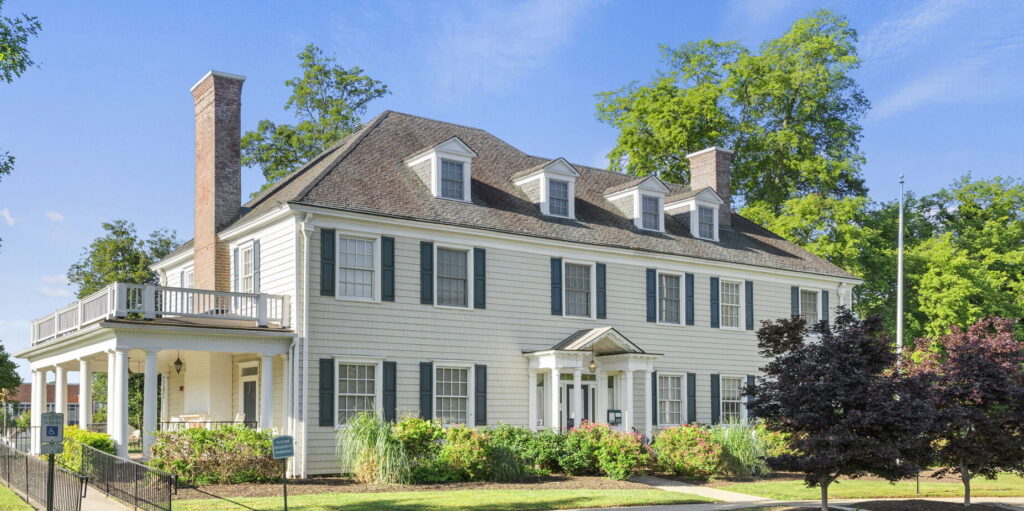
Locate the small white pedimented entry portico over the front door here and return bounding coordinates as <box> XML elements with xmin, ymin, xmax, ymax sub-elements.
<box><xmin>523</xmin><ymin>327</ymin><xmax>660</xmax><ymax>435</ymax></box>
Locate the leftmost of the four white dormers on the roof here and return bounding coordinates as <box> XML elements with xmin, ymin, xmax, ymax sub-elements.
<box><xmin>406</xmin><ymin>136</ymin><xmax>476</xmax><ymax>202</ymax></box>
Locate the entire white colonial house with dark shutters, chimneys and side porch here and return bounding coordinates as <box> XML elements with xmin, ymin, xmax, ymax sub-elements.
<box><xmin>18</xmin><ymin>72</ymin><xmax>858</xmax><ymax>476</ymax></box>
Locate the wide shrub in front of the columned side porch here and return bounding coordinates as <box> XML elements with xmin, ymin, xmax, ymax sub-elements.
<box><xmin>150</xmin><ymin>425</ymin><xmax>281</xmax><ymax>484</ymax></box>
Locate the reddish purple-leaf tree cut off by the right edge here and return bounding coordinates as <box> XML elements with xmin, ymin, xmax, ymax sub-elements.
<box><xmin>907</xmin><ymin>317</ymin><xmax>1024</xmax><ymax>506</ymax></box>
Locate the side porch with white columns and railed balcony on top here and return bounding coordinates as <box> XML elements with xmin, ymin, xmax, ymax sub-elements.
<box><xmin>17</xmin><ymin>285</ymin><xmax>294</xmax><ymax>458</ymax></box>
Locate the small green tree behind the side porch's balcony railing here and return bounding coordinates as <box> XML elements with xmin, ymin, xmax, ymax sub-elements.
<box><xmin>68</xmin><ymin>220</ymin><xmax>180</xmax><ymax>298</ymax></box>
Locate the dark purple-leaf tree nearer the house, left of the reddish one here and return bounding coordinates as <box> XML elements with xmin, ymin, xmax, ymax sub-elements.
<box><xmin>746</xmin><ymin>308</ymin><xmax>932</xmax><ymax>510</ymax></box>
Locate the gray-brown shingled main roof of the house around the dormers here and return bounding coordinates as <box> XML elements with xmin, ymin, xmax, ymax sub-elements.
<box><xmin>167</xmin><ymin>111</ymin><xmax>853</xmax><ymax>278</ymax></box>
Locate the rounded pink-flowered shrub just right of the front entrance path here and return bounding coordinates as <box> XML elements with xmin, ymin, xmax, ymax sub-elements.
<box><xmin>653</xmin><ymin>424</ymin><xmax>722</xmax><ymax>479</ymax></box>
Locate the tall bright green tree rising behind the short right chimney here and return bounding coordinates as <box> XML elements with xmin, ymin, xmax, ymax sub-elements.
<box><xmin>597</xmin><ymin>10</ymin><xmax>868</xmax><ymax>213</ymax></box>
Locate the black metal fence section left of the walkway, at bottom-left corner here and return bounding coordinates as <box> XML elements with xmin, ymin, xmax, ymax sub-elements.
<box><xmin>0</xmin><ymin>443</ymin><xmax>86</xmax><ymax>511</ymax></box>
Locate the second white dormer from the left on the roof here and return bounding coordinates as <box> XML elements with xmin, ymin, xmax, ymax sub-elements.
<box><xmin>512</xmin><ymin>158</ymin><xmax>580</xmax><ymax>219</ymax></box>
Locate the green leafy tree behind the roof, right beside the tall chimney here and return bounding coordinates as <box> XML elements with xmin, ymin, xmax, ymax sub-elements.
<box><xmin>242</xmin><ymin>44</ymin><xmax>389</xmax><ymax>188</ymax></box>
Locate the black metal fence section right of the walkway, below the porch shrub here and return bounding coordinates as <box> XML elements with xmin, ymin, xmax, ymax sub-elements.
<box><xmin>72</xmin><ymin>443</ymin><xmax>178</xmax><ymax>511</ymax></box>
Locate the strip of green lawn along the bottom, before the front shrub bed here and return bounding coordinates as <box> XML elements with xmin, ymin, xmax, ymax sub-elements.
<box><xmin>174</xmin><ymin>489</ymin><xmax>714</xmax><ymax>511</ymax></box>
